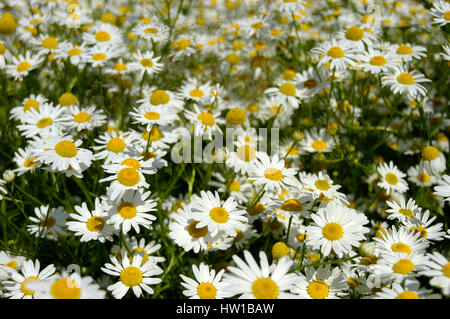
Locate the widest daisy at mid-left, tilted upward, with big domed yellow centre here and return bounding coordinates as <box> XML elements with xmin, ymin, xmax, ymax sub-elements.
<box><xmin>32</xmin><ymin>135</ymin><xmax>94</xmax><ymax>173</ymax></box>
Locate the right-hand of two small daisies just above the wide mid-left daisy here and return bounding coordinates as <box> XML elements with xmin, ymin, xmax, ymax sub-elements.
<box><xmin>64</xmin><ymin>105</ymin><xmax>106</xmax><ymax>132</ymax></box>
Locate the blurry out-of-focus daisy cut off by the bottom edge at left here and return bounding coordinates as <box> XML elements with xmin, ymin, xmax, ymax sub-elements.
<box><xmin>27</xmin><ymin>265</ymin><xmax>106</xmax><ymax>299</ymax></box>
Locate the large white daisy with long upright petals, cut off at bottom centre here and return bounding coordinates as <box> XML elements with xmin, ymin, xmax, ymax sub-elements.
<box><xmin>223</xmin><ymin>250</ymin><xmax>299</xmax><ymax>299</ymax></box>
